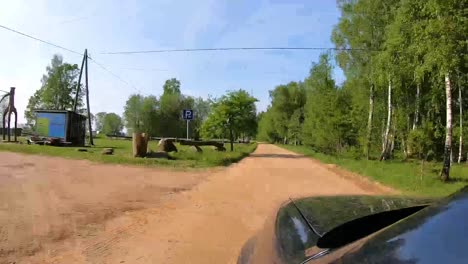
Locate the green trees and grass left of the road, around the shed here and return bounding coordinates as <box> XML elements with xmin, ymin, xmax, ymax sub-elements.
<box><xmin>13</xmin><ymin>55</ymin><xmax>257</xmax><ymax>168</ymax></box>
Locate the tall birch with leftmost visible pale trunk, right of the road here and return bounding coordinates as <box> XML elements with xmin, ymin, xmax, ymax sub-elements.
<box><xmin>332</xmin><ymin>0</ymin><xmax>399</xmax><ymax>159</ymax></box>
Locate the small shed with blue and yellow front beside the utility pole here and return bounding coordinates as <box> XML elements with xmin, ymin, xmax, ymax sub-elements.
<box><xmin>34</xmin><ymin>110</ymin><xmax>86</xmax><ymax>146</ymax></box>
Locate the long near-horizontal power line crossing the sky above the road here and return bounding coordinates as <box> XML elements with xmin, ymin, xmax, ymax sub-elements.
<box><xmin>100</xmin><ymin>47</ymin><xmax>375</xmax><ymax>55</ymax></box>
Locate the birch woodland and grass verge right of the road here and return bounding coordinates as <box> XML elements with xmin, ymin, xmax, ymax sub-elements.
<box><xmin>258</xmin><ymin>0</ymin><xmax>468</xmax><ymax>195</ymax></box>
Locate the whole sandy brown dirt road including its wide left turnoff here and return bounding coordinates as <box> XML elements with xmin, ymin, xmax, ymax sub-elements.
<box><xmin>0</xmin><ymin>144</ymin><xmax>391</xmax><ymax>263</ymax></box>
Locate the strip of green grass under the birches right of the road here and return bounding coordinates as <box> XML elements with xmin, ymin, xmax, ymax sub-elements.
<box><xmin>280</xmin><ymin>145</ymin><xmax>468</xmax><ymax>197</ymax></box>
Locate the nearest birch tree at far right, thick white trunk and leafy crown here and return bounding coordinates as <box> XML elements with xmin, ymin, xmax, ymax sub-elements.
<box><xmin>388</xmin><ymin>0</ymin><xmax>468</xmax><ymax>181</ymax></box>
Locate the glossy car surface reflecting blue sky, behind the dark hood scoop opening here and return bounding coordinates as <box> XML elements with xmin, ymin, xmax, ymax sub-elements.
<box><xmin>324</xmin><ymin>188</ymin><xmax>468</xmax><ymax>264</ymax></box>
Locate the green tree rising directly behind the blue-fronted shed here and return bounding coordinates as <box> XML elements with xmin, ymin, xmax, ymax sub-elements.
<box><xmin>24</xmin><ymin>55</ymin><xmax>83</xmax><ymax>124</ymax></box>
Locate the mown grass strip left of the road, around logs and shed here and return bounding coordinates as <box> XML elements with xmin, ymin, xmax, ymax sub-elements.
<box><xmin>0</xmin><ymin>138</ymin><xmax>257</xmax><ymax>168</ymax></box>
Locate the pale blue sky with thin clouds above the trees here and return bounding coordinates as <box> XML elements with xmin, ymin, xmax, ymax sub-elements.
<box><xmin>0</xmin><ymin>0</ymin><xmax>344</xmax><ymax>122</ymax></box>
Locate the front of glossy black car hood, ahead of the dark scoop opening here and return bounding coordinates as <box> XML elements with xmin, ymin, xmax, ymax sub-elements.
<box><xmin>238</xmin><ymin>196</ymin><xmax>435</xmax><ymax>264</ymax></box>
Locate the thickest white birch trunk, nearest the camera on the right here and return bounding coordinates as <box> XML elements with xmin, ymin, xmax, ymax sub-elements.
<box><xmin>440</xmin><ymin>72</ymin><xmax>452</xmax><ymax>181</ymax></box>
